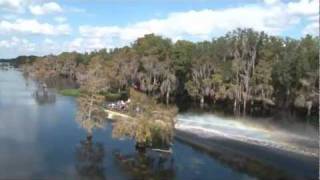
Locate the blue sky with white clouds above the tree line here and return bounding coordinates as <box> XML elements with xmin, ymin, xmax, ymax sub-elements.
<box><xmin>0</xmin><ymin>0</ymin><xmax>319</xmax><ymax>58</ymax></box>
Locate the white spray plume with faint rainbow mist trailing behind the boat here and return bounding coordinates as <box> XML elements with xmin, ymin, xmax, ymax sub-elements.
<box><xmin>176</xmin><ymin>113</ymin><xmax>319</xmax><ymax>156</ymax></box>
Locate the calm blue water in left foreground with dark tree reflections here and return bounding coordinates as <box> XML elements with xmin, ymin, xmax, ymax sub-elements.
<box><xmin>0</xmin><ymin>69</ymin><xmax>316</xmax><ymax>180</ymax></box>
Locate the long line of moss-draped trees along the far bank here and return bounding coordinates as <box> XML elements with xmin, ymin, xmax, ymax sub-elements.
<box><xmin>19</xmin><ymin>29</ymin><xmax>320</xmax><ymax>115</ymax></box>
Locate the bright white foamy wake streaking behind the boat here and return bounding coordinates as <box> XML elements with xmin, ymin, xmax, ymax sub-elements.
<box><xmin>175</xmin><ymin>113</ymin><xmax>318</xmax><ymax>156</ymax></box>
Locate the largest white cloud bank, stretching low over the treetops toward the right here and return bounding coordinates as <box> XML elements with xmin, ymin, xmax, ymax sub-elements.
<box><xmin>74</xmin><ymin>5</ymin><xmax>300</xmax><ymax>49</ymax></box>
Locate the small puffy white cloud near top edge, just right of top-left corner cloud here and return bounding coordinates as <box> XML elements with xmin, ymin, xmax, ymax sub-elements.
<box><xmin>29</xmin><ymin>2</ymin><xmax>63</xmax><ymax>15</ymax></box>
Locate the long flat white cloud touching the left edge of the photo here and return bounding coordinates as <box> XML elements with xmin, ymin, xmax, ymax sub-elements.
<box><xmin>0</xmin><ymin>19</ymin><xmax>71</xmax><ymax>35</ymax></box>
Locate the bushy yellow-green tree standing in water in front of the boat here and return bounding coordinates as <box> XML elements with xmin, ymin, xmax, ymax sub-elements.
<box><xmin>113</xmin><ymin>89</ymin><xmax>177</xmax><ymax>146</ymax></box>
